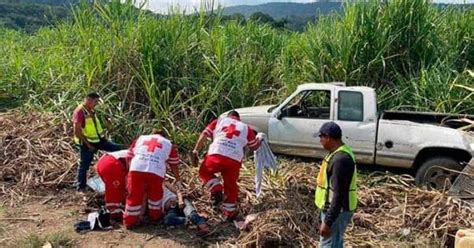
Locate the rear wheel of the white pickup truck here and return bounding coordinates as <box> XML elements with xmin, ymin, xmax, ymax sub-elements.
<box><xmin>415</xmin><ymin>157</ymin><xmax>463</xmax><ymax>190</ymax></box>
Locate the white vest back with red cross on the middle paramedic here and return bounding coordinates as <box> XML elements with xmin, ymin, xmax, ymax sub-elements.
<box><xmin>130</xmin><ymin>134</ymin><xmax>172</xmax><ymax>178</ymax></box>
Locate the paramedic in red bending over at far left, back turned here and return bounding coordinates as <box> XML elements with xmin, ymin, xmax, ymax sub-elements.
<box><xmin>96</xmin><ymin>150</ymin><xmax>129</xmax><ymax>220</ymax></box>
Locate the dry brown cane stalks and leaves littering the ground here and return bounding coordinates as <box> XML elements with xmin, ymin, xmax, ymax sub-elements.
<box><xmin>0</xmin><ymin>112</ymin><xmax>474</xmax><ymax>247</ymax></box>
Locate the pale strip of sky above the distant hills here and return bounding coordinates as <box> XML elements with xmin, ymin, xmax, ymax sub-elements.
<box><xmin>139</xmin><ymin>0</ymin><xmax>474</xmax><ymax>13</ymax></box>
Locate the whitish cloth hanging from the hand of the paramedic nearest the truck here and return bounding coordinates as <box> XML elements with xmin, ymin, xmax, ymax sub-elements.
<box><xmin>254</xmin><ymin>133</ymin><xmax>278</xmax><ymax>197</ymax></box>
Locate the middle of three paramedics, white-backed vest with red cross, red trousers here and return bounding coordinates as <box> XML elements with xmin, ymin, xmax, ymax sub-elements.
<box><xmin>123</xmin><ymin>132</ymin><xmax>181</xmax><ymax>228</ymax></box>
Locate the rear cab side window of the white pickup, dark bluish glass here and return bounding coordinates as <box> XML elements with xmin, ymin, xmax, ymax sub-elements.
<box><xmin>337</xmin><ymin>91</ymin><xmax>364</xmax><ymax>121</ymax></box>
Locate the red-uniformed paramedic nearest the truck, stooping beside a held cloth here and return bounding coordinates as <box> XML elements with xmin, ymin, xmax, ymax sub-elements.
<box><xmin>193</xmin><ymin>111</ymin><xmax>260</xmax><ymax>220</ymax></box>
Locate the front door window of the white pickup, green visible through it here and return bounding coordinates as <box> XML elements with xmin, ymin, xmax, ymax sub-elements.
<box><xmin>283</xmin><ymin>90</ymin><xmax>331</xmax><ymax>120</ymax></box>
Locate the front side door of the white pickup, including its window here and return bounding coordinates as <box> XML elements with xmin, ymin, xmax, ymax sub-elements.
<box><xmin>268</xmin><ymin>89</ymin><xmax>334</xmax><ymax>157</ymax></box>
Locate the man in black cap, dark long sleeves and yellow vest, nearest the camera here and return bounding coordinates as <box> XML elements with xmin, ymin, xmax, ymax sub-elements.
<box><xmin>314</xmin><ymin>122</ymin><xmax>357</xmax><ymax>247</ymax></box>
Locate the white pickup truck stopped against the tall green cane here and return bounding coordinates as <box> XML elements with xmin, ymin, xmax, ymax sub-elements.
<box><xmin>236</xmin><ymin>83</ymin><xmax>474</xmax><ymax>188</ymax></box>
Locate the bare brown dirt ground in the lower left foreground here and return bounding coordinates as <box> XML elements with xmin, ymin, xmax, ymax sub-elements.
<box><xmin>0</xmin><ymin>189</ymin><xmax>238</xmax><ymax>247</ymax></box>
